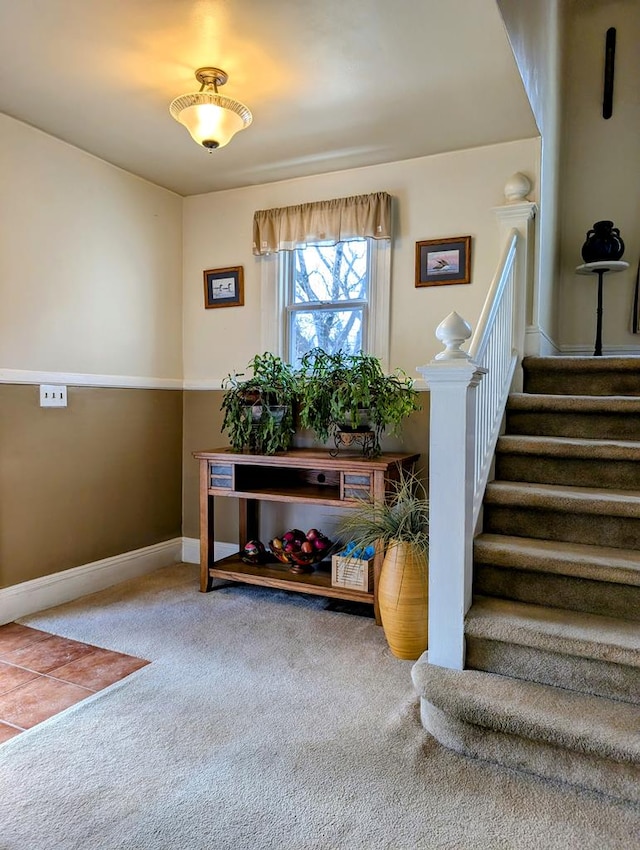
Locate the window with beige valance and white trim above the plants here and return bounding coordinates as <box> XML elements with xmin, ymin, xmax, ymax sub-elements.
<box><xmin>253</xmin><ymin>192</ymin><xmax>391</xmax><ymax>369</ymax></box>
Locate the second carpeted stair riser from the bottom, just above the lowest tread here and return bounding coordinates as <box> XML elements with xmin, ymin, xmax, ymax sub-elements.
<box><xmin>465</xmin><ymin>636</ymin><xmax>640</xmax><ymax>705</ymax></box>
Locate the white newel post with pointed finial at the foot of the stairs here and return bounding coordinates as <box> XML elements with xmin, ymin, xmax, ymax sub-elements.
<box><xmin>417</xmin><ymin>313</ymin><xmax>486</xmax><ymax>670</ymax></box>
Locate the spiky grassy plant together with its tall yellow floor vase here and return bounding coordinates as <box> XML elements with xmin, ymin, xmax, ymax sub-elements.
<box><xmin>338</xmin><ymin>470</ymin><xmax>429</xmax><ymax>660</ymax></box>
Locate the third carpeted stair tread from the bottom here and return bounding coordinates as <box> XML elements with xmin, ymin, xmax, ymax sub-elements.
<box><xmin>474</xmin><ymin>534</ymin><xmax>640</xmax><ymax>586</ymax></box>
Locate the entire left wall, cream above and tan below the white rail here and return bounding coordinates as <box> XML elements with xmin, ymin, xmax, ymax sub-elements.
<box><xmin>0</xmin><ymin>116</ymin><xmax>182</xmax><ymax>585</ymax></box>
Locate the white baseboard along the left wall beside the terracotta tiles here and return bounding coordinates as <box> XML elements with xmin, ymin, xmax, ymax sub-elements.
<box><xmin>0</xmin><ymin>537</ymin><xmax>182</xmax><ymax>624</ymax></box>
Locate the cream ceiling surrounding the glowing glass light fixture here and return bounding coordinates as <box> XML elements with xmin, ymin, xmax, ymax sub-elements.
<box><xmin>0</xmin><ymin>0</ymin><xmax>537</xmax><ymax>195</ymax></box>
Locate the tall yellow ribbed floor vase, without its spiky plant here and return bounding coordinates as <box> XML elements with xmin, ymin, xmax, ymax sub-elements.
<box><xmin>378</xmin><ymin>540</ymin><xmax>429</xmax><ymax>661</ymax></box>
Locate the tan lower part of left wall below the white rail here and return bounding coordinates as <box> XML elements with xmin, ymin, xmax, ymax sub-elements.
<box><xmin>0</xmin><ymin>384</ymin><xmax>182</xmax><ymax>586</ymax></box>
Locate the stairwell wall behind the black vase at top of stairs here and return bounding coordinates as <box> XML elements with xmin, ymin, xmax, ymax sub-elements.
<box><xmin>559</xmin><ymin>0</ymin><xmax>640</xmax><ymax>354</ymax></box>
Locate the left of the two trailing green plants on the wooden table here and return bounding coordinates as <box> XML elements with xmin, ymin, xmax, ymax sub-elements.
<box><xmin>220</xmin><ymin>351</ymin><xmax>298</xmax><ymax>454</ymax></box>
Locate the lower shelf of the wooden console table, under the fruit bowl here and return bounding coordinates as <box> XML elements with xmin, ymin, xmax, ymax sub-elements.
<box><xmin>208</xmin><ymin>555</ymin><xmax>374</xmax><ymax>605</ymax></box>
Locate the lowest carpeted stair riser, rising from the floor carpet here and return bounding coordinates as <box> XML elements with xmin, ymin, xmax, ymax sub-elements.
<box><xmin>420</xmin><ymin>696</ymin><xmax>640</xmax><ymax>803</ymax></box>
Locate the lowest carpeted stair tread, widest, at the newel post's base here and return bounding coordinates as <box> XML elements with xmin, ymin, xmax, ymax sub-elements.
<box><xmin>412</xmin><ymin>653</ymin><xmax>640</xmax><ymax>765</ymax></box>
